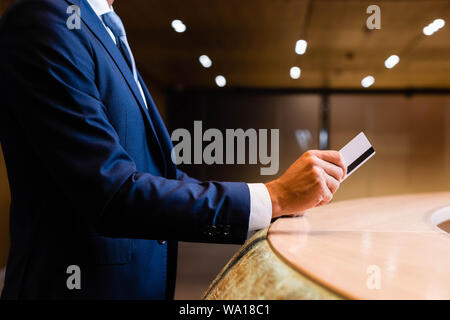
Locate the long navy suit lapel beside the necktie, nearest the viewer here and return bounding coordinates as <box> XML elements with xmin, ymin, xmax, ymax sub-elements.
<box><xmin>66</xmin><ymin>0</ymin><xmax>167</xmax><ymax>172</ymax></box>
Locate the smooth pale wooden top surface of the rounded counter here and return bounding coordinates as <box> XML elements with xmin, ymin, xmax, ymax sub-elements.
<box><xmin>268</xmin><ymin>193</ymin><xmax>450</xmax><ymax>299</ymax></box>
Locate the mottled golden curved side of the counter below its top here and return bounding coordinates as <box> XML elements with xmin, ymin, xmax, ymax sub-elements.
<box><xmin>203</xmin><ymin>228</ymin><xmax>344</xmax><ymax>300</ymax></box>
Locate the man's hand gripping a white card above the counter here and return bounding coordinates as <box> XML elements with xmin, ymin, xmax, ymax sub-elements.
<box><xmin>266</xmin><ymin>150</ymin><xmax>347</xmax><ymax>218</ymax></box>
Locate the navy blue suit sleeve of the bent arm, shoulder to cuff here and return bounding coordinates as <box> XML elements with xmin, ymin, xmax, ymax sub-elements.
<box><xmin>0</xmin><ymin>2</ymin><xmax>250</xmax><ymax>243</ymax></box>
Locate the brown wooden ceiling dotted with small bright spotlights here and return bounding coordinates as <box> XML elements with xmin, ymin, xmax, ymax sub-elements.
<box><xmin>114</xmin><ymin>0</ymin><xmax>450</xmax><ymax>88</ymax></box>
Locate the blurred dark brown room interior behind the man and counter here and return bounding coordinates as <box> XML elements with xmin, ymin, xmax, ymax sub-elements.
<box><xmin>0</xmin><ymin>0</ymin><xmax>450</xmax><ymax>299</ymax></box>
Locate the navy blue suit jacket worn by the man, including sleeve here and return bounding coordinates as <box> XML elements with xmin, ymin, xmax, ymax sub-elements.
<box><xmin>0</xmin><ymin>0</ymin><xmax>250</xmax><ymax>299</ymax></box>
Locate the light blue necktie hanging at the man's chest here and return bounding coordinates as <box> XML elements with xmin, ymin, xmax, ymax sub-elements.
<box><xmin>102</xmin><ymin>11</ymin><xmax>147</xmax><ymax>106</ymax></box>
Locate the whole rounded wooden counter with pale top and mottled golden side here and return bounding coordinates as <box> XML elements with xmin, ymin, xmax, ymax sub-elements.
<box><xmin>205</xmin><ymin>192</ymin><xmax>450</xmax><ymax>299</ymax></box>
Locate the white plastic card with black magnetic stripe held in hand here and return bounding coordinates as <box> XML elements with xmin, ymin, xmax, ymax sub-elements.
<box><xmin>339</xmin><ymin>132</ymin><xmax>375</xmax><ymax>180</ymax></box>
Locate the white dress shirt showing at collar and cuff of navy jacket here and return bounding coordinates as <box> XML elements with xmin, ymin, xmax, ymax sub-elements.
<box><xmin>87</xmin><ymin>0</ymin><xmax>272</xmax><ymax>233</ymax></box>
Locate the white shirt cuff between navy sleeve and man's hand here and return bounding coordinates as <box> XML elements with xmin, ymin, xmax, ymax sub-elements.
<box><xmin>247</xmin><ymin>183</ymin><xmax>272</xmax><ymax>233</ymax></box>
